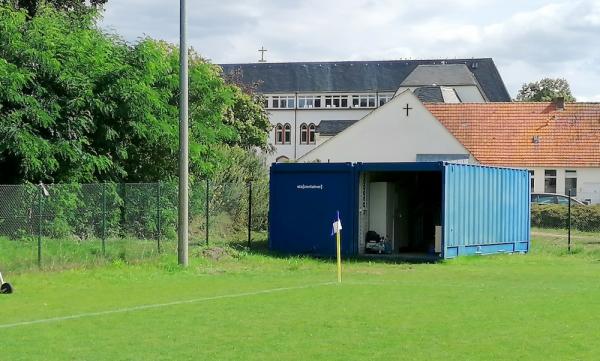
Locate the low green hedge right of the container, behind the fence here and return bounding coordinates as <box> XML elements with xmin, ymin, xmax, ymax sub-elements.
<box><xmin>531</xmin><ymin>204</ymin><xmax>600</xmax><ymax>231</ymax></box>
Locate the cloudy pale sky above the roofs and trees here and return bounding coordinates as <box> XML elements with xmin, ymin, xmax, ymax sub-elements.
<box><xmin>103</xmin><ymin>0</ymin><xmax>600</xmax><ymax>101</ymax></box>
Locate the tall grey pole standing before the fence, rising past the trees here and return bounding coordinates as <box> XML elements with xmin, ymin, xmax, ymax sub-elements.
<box><xmin>177</xmin><ymin>0</ymin><xmax>188</xmax><ymax>267</ymax></box>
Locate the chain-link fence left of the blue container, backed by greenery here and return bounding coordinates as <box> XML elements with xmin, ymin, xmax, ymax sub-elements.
<box><xmin>0</xmin><ymin>181</ymin><xmax>268</xmax><ymax>269</ymax></box>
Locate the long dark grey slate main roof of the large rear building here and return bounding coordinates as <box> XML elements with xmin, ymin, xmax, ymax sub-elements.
<box><xmin>221</xmin><ymin>58</ymin><xmax>510</xmax><ymax>102</ymax></box>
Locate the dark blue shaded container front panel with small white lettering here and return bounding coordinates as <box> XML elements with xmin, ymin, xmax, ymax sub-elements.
<box><xmin>269</xmin><ymin>163</ymin><xmax>357</xmax><ymax>256</ymax></box>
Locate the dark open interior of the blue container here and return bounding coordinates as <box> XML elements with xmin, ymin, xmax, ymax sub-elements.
<box><xmin>358</xmin><ymin>171</ymin><xmax>443</xmax><ymax>257</ymax></box>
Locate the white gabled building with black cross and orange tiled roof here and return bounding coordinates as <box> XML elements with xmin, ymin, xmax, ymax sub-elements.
<box><xmin>299</xmin><ymin>91</ymin><xmax>600</xmax><ymax>204</ymax></box>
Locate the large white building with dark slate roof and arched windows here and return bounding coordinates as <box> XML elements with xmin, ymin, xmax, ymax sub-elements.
<box><xmin>221</xmin><ymin>58</ymin><xmax>511</xmax><ymax>163</ymax></box>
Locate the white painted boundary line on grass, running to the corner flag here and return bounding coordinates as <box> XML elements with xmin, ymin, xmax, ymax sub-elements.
<box><xmin>0</xmin><ymin>282</ymin><xmax>337</xmax><ymax>329</ymax></box>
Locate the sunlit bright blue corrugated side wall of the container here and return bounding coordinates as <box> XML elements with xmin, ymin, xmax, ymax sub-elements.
<box><xmin>444</xmin><ymin>164</ymin><xmax>530</xmax><ymax>258</ymax></box>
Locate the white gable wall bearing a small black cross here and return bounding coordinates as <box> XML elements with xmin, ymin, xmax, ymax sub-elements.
<box><xmin>298</xmin><ymin>91</ymin><xmax>469</xmax><ymax>162</ymax></box>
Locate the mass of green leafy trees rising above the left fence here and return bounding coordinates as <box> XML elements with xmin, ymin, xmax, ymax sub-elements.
<box><xmin>0</xmin><ymin>5</ymin><xmax>270</xmax><ymax>183</ymax></box>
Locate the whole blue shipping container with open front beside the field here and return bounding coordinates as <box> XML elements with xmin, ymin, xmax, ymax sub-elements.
<box><xmin>269</xmin><ymin>162</ymin><xmax>530</xmax><ymax>258</ymax></box>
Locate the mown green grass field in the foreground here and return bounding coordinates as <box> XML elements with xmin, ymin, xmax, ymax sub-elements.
<box><xmin>0</xmin><ymin>230</ymin><xmax>600</xmax><ymax>360</ymax></box>
